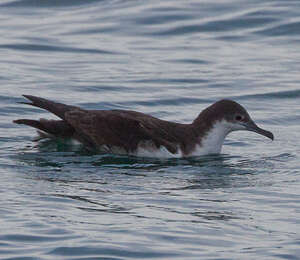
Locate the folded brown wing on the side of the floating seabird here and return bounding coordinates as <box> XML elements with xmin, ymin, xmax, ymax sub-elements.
<box><xmin>65</xmin><ymin>109</ymin><xmax>177</xmax><ymax>153</ymax></box>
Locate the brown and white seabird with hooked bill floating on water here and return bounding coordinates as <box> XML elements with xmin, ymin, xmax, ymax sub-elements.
<box><xmin>13</xmin><ymin>95</ymin><xmax>274</xmax><ymax>157</ymax></box>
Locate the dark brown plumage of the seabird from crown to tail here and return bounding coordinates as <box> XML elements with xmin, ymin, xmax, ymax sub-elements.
<box><xmin>14</xmin><ymin>95</ymin><xmax>271</xmax><ymax>156</ymax></box>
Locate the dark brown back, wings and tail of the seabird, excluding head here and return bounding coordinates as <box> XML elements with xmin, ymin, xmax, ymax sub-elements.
<box><xmin>14</xmin><ymin>95</ymin><xmax>196</xmax><ymax>153</ymax></box>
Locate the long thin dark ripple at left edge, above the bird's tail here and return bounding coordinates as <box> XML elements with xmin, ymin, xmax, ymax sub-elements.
<box><xmin>0</xmin><ymin>44</ymin><xmax>120</xmax><ymax>55</ymax></box>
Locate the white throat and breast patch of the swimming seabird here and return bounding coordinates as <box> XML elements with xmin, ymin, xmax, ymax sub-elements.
<box><xmin>192</xmin><ymin>120</ymin><xmax>236</xmax><ymax>156</ymax></box>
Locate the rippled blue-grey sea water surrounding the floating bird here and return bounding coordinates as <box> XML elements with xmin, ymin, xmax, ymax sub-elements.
<box><xmin>0</xmin><ymin>0</ymin><xmax>300</xmax><ymax>260</ymax></box>
